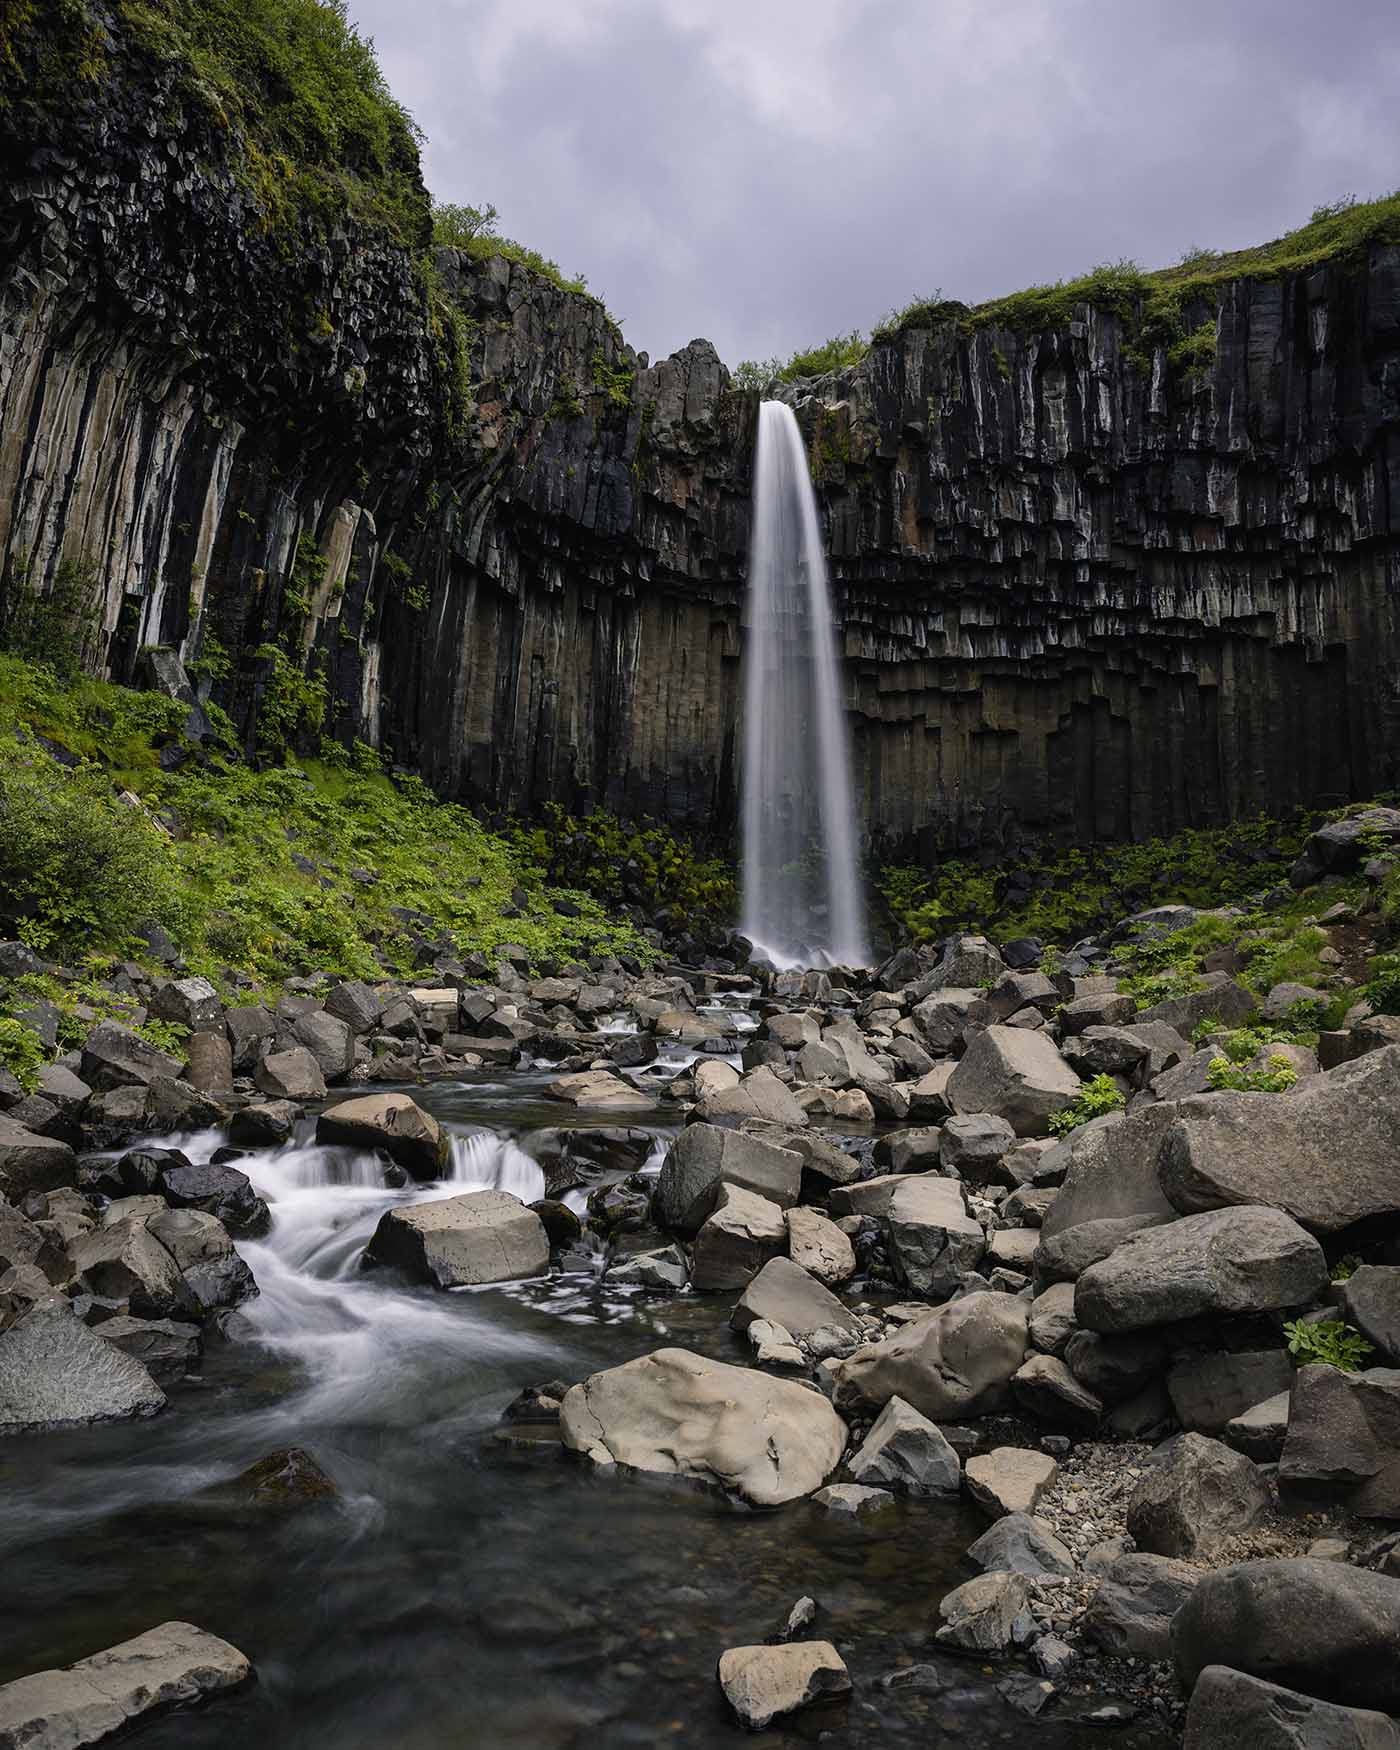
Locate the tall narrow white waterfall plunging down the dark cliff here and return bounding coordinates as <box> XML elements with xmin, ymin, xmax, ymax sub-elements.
<box><xmin>742</xmin><ymin>401</ymin><xmax>870</xmax><ymax>966</ymax></box>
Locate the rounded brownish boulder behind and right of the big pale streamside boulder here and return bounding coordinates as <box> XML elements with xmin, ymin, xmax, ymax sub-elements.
<box><xmin>831</xmin><ymin>1293</ymin><xmax>1027</xmax><ymax>1423</ymax></box>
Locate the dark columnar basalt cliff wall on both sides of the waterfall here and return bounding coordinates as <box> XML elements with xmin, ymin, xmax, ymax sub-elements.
<box><xmin>0</xmin><ymin>0</ymin><xmax>1400</xmax><ymax>852</ymax></box>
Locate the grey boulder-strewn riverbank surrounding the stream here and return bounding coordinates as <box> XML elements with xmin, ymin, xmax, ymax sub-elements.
<box><xmin>0</xmin><ymin>810</ymin><xmax>1400</xmax><ymax>1747</ymax></box>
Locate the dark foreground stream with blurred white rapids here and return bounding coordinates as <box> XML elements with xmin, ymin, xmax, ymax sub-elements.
<box><xmin>0</xmin><ymin>1076</ymin><xmax>1167</xmax><ymax>1750</ymax></box>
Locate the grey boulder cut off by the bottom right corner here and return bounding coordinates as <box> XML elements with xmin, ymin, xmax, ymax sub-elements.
<box><xmin>1181</xmin><ymin>1664</ymin><xmax>1400</xmax><ymax>1750</ymax></box>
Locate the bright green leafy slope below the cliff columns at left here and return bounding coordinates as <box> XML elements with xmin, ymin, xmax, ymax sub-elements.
<box><xmin>0</xmin><ymin>656</ymin><xmax>655</xmax><ymax>978</ymax></box>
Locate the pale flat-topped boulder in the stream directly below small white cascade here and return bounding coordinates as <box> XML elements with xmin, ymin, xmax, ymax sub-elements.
<box><xmin>366</xmin><ymin>1190</ymin><xmax>550</xmax><ymax>1288</ymax></box>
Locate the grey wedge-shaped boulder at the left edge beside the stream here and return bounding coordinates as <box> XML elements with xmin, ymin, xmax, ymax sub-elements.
<box><xmin>0</xmin><ymin>1299</ymin><xmax>165</xmax><ymax>1433</ymax></box>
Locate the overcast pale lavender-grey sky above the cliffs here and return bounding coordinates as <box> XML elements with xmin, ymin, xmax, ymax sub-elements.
<box><xmin>350</xmin><ymin>0</ymin><xmax>1400</xmax><ymax>364</ymax></box>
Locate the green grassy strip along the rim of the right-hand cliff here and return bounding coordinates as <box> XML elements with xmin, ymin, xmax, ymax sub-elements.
<box><xmin>872</xmin><ymin>191</ymin><xmax>1400</xmax><ymax>343</ymax></box>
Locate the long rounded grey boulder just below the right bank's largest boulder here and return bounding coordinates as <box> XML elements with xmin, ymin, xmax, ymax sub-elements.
<box><xmin>1075</xmin><ymin>1208</ymin><xmax>1327</xmax><ymax>1332</ymax></box>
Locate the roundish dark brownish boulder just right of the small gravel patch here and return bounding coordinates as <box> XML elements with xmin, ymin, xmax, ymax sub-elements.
<box><xmin>1127</xmin><ymin>1433</ymin><xmax>1269</xmax><ymax>1561</ymax></box>
